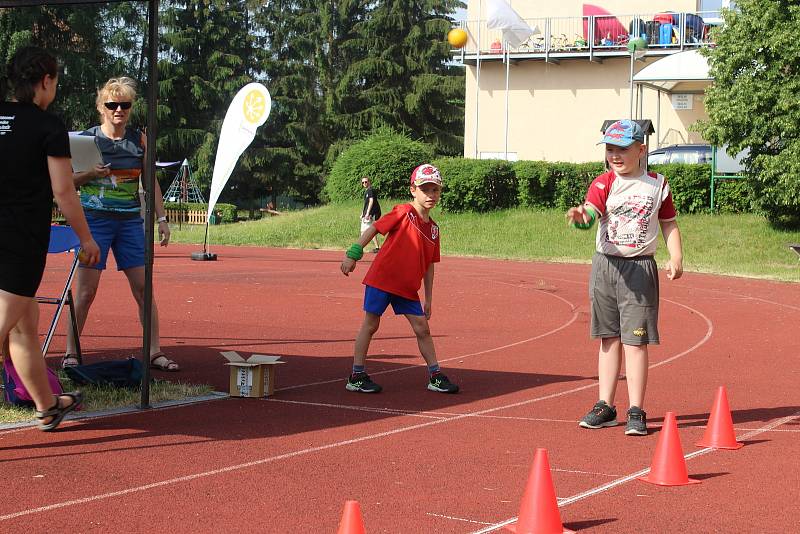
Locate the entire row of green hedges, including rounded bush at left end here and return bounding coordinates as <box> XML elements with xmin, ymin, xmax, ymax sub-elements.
<box><xmin>325</xmin><ymin>147</ymin><xmax>753</xmax><ymax>213</ymax></box>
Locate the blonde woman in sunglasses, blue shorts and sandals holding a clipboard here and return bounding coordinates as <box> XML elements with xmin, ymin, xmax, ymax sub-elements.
<box><xmin>63</xmin><ymin>77</ymin><xmax>180</xmax><ymax>371</ymax></box>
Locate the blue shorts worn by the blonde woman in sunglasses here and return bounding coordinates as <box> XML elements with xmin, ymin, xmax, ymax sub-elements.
<box><xmin>81</xmin><ymin>214</ymin><xmax>144</xmax><ymax>271</ymax></box>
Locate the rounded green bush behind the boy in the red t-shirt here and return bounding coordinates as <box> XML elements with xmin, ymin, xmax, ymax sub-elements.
<box><xmin>322</xmin><ymin>130</ymin><xmax>433</xmax><ymax>202</ymax></box>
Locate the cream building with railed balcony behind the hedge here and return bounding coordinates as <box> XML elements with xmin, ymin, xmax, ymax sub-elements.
<box><xmin>454</xmin><ymin>0</ymin><xmax>731</xmax><ymax>162</ymax></box>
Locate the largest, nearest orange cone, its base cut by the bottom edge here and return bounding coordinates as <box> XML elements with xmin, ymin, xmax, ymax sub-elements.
<box><xmin>506</xmin><ymin>449</ymin><xmax>573</xmax><ymax>534</ymax></box>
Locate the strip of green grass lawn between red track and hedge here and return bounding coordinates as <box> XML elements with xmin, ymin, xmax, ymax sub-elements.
<box><xmin>172</xmin><ymin>200</ymin><xmax>800</xmax><ymax>282</ymax></box>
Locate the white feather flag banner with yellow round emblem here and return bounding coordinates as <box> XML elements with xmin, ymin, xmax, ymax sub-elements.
<box><xmin>206</xmin><ymin>83</ymin><xmax>272</xmax><ymax>220</ymax></box>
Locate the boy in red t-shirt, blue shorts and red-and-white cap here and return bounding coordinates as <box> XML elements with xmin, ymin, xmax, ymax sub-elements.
<box><xmin>341</xmin><ymin>163</ymin><xmax>458</xmax><ymax>393</ymax></box>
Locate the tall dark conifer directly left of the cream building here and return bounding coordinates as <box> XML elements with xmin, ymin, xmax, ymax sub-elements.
<box><xmin>337</xmin><ymin>0</ymin><xmax>464</xmax><ymax>155</ymax></box>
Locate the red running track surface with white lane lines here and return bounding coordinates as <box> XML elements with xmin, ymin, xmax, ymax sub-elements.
<box><xmin>0</xmin><ymin>245</ymin><xmax>800</xmax><ymax>533</ymax></box>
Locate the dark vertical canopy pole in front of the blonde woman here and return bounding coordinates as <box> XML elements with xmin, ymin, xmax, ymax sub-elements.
<box><xmin>139</xmin><ymin>0</ymin><xmax>158</xmax><ymax>409</ymax></box>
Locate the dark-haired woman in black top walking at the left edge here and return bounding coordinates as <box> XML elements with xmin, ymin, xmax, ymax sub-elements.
<box><xmin>0</xmin><ymin>47</ymin><xmax>100</xmax><ymax>431</ymax></box>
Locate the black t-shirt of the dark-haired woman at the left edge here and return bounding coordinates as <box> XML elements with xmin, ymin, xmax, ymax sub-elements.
<box><xmin>0</xmin><ymin>102</ymin><xmax>70</xmax><ymax>263</ymax></box>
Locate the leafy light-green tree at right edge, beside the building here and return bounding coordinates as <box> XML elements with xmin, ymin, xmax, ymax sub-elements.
<box><xmin>700</xmin><ymin>0</ymin><xmax>800</xmax><ymax>226</ymax></box>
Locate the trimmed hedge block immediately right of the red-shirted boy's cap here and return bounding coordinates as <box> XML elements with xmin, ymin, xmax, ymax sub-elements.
<box><xmin>432</xmin><ymin>158</ymin><xmax>517</xmax><ymax>212</ymax></box>
